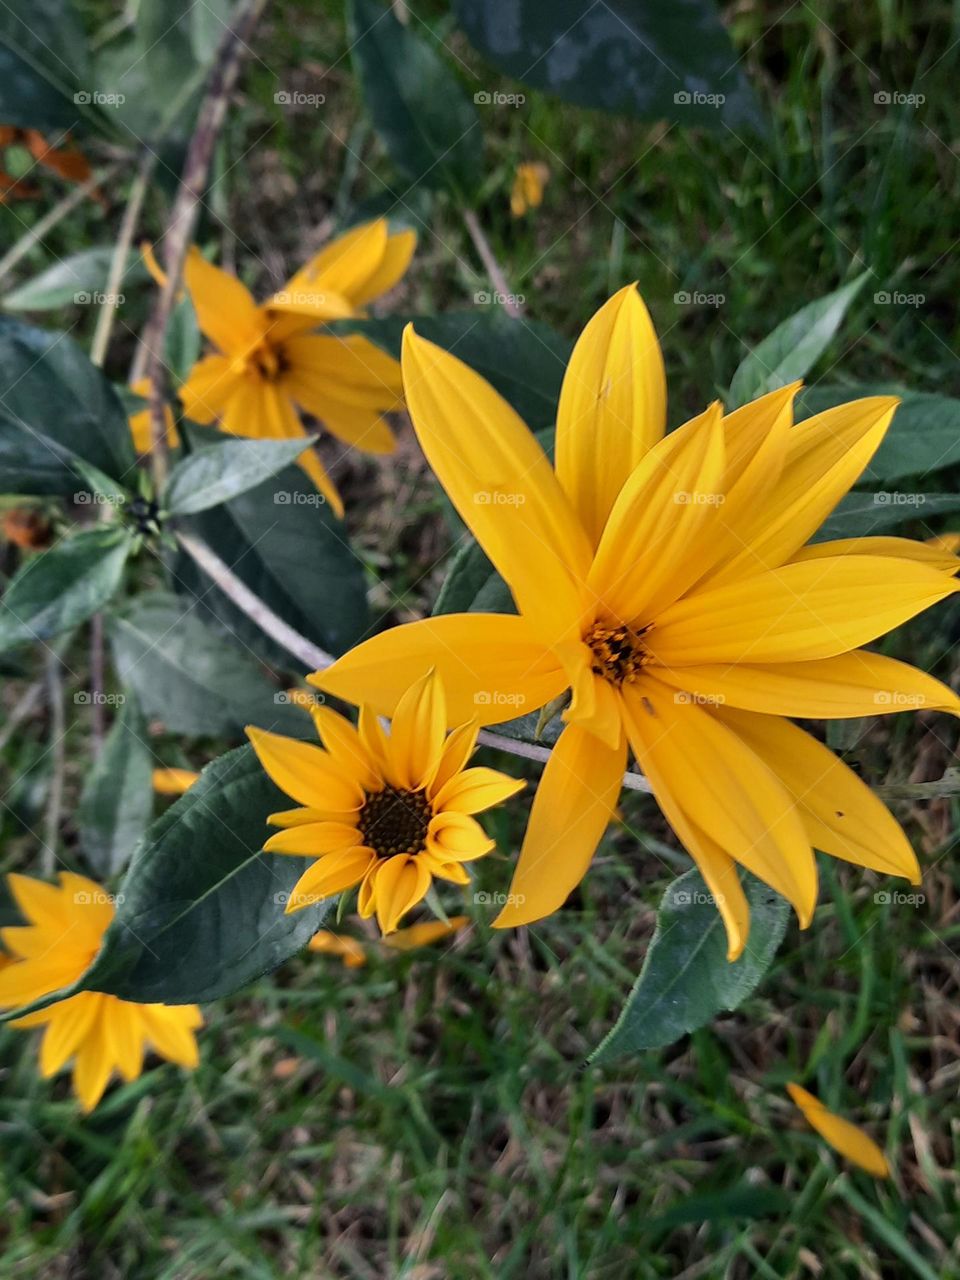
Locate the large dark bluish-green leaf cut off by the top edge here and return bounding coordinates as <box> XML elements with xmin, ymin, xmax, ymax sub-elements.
<box><xmin>454</xmin><ymin>0</ymin><xmax>762</xmax><ymax>131</ymax></box>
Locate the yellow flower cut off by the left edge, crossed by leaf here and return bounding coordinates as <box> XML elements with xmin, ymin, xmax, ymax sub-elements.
<box><xmin>0</xmin><ymin>872</ymin><xmax>204</xmax><ymax>1111</ymax></box>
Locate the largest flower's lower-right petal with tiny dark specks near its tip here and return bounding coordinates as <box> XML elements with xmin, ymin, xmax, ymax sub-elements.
<box><xmin>714</xmin><ymin>707</ymin><xmax>920</xmax><ymax>884</ymax></box>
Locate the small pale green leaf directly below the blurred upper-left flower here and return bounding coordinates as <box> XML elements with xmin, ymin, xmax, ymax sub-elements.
<box><xmin>163</xmin><ymin>436</ymin><xmax>317</xmax><ymax>516</ymax></box>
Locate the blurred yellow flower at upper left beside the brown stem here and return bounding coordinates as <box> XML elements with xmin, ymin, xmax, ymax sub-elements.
<box><xmin>151</xmin><ymin>219</ymin><xmax>416</xmax><ymax>516</ymax></box>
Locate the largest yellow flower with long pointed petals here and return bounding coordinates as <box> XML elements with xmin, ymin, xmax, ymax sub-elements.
<box><xmin>310</xmin><ymin>287</ymin><xmax>960</xmax><ymax>956</ymax></box>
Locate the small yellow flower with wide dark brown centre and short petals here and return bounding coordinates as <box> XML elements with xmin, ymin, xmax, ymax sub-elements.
<box><xmin>247</xmin><ymin>671</ymin><xmax>524</xmax><ymax>933</ymax></box>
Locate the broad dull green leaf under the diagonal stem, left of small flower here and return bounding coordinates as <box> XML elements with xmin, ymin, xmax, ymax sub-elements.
<box><xmin>110</xmin><ymin>591</ymin><xmax>311</xmax><ymax>737</ymax></box>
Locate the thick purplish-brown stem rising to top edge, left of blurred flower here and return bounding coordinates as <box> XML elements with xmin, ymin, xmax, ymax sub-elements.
<box><xmin>143</xmin><ymin>0</ymin><xmax>268</xmax><ymax>492</ymax></box>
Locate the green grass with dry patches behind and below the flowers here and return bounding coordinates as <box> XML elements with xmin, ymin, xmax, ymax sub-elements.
<box><xmin>0</xmin><ymin>0</ymin><xmax>960</xmax><ymax>1280</ymax></box>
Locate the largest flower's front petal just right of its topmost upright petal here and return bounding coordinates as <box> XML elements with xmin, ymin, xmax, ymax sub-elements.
<box><xmin>589</xmin><ymin>403</ymin><xmax>724</xmax><ymax>622</ymax></box>
